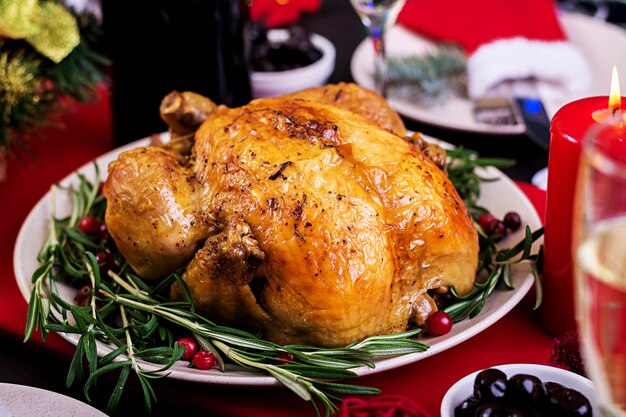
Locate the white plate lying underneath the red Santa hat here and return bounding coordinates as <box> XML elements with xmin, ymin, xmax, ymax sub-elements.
<box><xmin>350</xmin><ymin>13</ymin><xmax>626</xmax><ymax>135</ymax></box>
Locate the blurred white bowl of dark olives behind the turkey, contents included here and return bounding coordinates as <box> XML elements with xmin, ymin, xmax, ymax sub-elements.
<box><xmin>250</xmin><ymin>26</ymin><xmax>336</xmax><ymax>98</ymax></box>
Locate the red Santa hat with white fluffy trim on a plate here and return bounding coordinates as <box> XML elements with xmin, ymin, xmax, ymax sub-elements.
<box><xmin>398</xmin><ymin>0</ymin><xmax>591</xmax><ymax>98</ymax></box>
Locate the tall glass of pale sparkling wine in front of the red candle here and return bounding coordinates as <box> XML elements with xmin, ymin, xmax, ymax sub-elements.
<box><xmin>574</xmin><ymin>117</ymin><xmax>626</xmax><ymax>417</ymax></box>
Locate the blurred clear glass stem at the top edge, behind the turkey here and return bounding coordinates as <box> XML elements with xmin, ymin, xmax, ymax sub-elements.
<box><xmin>350</xmin><ymin>0</ymin><xmax>406</xmax><ymax>98</ymax></box>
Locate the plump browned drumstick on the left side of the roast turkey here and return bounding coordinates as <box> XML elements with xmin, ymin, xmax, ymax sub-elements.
<box><xmin>103</xmin><ymin>146</ymin><xmax>214</xmax><ymax>279</ymax></box>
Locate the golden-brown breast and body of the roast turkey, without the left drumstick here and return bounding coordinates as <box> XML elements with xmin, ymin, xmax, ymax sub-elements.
<box><xmin>168</xmin><ymin>98</ymin><xmax>478</xmax><ymax>346</ymax></box>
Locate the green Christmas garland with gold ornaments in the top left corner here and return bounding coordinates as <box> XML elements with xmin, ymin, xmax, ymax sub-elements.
<box><xmin>0</xmin><ymin>0</ymin><xmax>108</xmax><ymax>181</ymax></box>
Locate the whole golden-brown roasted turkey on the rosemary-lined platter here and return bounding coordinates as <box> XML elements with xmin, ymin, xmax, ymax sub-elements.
<box><xmin>104</xmin><ymin>84</ymin><xmax>478</xmax><ymax>347</ymax></box>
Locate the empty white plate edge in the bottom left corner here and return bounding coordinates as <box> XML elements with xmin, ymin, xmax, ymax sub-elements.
<box><xmin>0</xmin><ymin>384</ymin><xmax>106</xmax><ymax>417</ymax></box>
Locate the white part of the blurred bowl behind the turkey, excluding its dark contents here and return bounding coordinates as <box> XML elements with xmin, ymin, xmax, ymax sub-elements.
<box><xmin>251</xmin><ymin>29</ymin><xmax>336</xmax><ymax>98</ymax></box>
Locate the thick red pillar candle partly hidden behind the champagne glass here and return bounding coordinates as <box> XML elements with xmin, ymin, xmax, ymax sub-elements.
<box><xmin>541</xmin><ymin>96</ymin><xmax>610</xmax><ymax>336</ymax></box>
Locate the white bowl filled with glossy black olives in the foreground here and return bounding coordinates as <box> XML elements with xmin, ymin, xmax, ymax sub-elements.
<box><xmin>441</xmin><ymin>364</ymin><xmax>600</xmax><ymax>417</ymax></box>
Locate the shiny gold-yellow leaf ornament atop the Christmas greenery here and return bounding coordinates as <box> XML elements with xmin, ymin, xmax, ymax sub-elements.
<box><xmin>0</xmin><ymin>0</ymin><xmax>80</xmax><ymax>64</ymax></box>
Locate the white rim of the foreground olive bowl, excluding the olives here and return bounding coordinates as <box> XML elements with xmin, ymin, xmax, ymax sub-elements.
<box><xmin>441</xmin><ymin>363</ymin><xmax>600</xmax><ymax>417</ymax></box>
